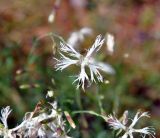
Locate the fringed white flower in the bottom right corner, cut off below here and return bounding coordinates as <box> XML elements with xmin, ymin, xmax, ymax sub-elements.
<box><xmin>107</xmin><ymin>112</ymin><xmax>155</xmax><ymax>138</ymax></box>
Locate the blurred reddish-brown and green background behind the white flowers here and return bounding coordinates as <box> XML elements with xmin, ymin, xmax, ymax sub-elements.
<box><xmin>0</xmin><ymin>0</ymin><xmax>160</xmax><ymax>138</ymax></box>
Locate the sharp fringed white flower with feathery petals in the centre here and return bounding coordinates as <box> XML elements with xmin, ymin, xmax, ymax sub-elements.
<box><xmin>55</xmin><ymin>35</ymin><xmax>114</xmax><ymax>90</ymax></box>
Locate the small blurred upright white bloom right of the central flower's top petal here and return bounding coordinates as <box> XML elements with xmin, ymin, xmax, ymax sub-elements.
<box><xmin>106</xmin><ymin>33</ymin><xmax>115</xmax><ymax>54</ymax></box>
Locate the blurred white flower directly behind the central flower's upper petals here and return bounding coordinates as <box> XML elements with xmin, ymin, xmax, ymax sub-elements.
<box><xmin>67</xmin><ymin>27</ymin><xmax>93</xmax><ymax>47</ymax></box>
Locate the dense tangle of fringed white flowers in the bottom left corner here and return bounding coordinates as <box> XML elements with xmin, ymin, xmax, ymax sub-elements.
<box><xmin>0</xmin><ymin>102</ymin><xmax>69</xmax><ymax>138</ymax></box>
